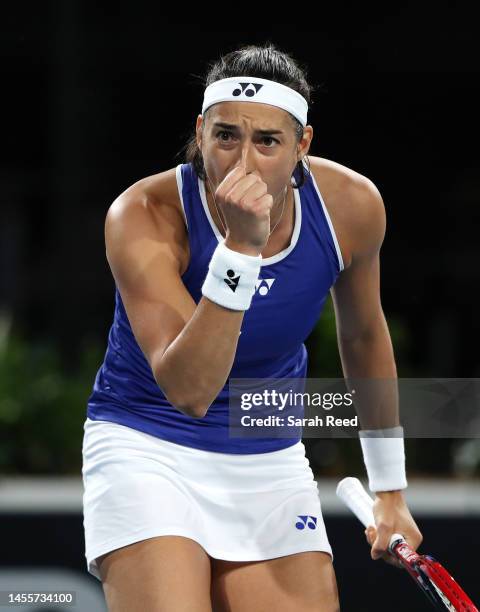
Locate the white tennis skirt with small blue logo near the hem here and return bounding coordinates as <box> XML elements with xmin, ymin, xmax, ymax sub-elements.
<box><xmin>82</xmin><ymin>418</ymin><xmax>333</xmax><ymax>579</ymax></box>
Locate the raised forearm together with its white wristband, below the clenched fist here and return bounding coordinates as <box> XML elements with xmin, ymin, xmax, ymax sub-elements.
<box><xmin>156</xmin><ymin>241</ymin><xmax>262</xmax><ymax>417</ymax></box>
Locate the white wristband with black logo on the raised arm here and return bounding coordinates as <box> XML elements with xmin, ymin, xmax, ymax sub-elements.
<box><xmin>202</xmin><ymin>241</ymin><xmax>262</xmax><ymax>310</ymax></box>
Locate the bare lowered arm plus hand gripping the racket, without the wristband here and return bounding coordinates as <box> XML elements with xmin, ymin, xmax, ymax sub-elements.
<box><xmin>332</xmin><ymin>175</ymin><xmax>422</xmax><ymax>566</ymax></box>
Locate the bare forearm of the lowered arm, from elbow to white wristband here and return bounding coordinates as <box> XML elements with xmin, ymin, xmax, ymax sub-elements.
<box><xmin>338</xmin><ymin>316</ymin><xmax>399</xmax><ymax>430</ymax></box>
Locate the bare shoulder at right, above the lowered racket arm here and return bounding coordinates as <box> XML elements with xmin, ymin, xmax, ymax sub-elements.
<box><xmin>309</xmin><ymin>156</ymin><xmax>385</xmax><ymax>268</ymax></box>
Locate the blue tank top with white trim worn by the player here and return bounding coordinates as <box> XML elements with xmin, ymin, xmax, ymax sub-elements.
<box><xmin>87</xmin><ymin>164</ymin><xmax>343</xmax><ymax>454</ymax></box>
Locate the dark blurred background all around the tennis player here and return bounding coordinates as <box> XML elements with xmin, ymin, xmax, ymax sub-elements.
<box><xmin>0</xmin><ymin>5</ymin><xmax>480</xmax><ymax>612</ymax></box>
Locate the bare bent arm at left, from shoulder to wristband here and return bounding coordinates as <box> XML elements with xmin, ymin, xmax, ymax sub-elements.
<box><xmin>105</xmin><ymin>171</ymin><xmax>244</xmax><ymax>417</ymax></box>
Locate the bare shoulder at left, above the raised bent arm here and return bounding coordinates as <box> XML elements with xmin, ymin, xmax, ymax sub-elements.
<box><xmin>105</xmin><ymin>168</ymin><xmax>188</xmax><ymax>272</ymax></box>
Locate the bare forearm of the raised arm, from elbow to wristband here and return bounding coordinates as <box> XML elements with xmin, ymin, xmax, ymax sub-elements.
<box><xmin>154</xmin><ymin>297</ymin><xmax>244</xmax><ymax>417</ymax></box>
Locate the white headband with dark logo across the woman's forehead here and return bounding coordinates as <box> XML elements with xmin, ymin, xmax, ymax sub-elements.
<box><xmin>202</xmin><ymin>77</ymin><xmax>308</xmax><ymax>127</ymax></box>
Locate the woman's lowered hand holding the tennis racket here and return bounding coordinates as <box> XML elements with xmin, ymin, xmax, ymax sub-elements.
<box><xmin>365</xmin><ymin>491</ymin><xmax>423</xmax><ymax>568</ymax></box>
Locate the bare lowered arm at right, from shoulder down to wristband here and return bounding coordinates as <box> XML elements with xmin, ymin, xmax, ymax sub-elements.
<box><xmin>332</xmin><ymin>179</ymin><xmax>398</xmax><ymax>429</ymax></box>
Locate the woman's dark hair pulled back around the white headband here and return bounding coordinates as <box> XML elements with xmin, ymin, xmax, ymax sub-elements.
<box><xmin>182</xmin><ymin>43</ymin><xmax>313</xmax><ymax>188</ymax></box>
